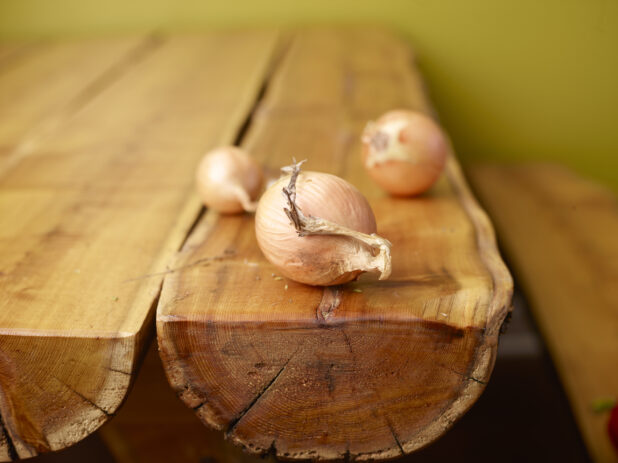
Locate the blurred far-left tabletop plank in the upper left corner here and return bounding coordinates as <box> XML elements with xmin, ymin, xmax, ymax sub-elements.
<box><xmin>0</xmin><ymin>37</ymin><xmax>157</xmax><ymax>172</ymax></box>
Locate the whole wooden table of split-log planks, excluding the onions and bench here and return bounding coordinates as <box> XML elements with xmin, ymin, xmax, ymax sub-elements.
<box><xmin>0</xmin><ymin>29</ymin><xmax>511</xmax><ymax>460</ymax></box>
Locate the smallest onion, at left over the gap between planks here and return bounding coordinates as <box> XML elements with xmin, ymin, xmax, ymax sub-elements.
<box><xmin>196</xmin><ymin>146</ymin><xmax>262</xmax><ymax>214</ymax></box>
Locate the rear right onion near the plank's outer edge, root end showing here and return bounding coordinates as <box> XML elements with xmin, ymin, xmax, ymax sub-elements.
<box><xmin>362</xmin><ymin>110</ymin><xmax>450</xmax><ymax>196</ymax></box>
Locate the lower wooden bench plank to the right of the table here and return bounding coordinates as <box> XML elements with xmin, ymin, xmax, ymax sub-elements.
<box><xmin>470</xmin><ymin>164</ymin><xmax>618</xmax><ymax>462</ymax></box>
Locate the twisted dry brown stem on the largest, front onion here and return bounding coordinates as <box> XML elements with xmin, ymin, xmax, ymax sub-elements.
<box><xmin>281</xmin><ymin>160</ymin><xmax>392</xmax><ymax>280</ymax></box>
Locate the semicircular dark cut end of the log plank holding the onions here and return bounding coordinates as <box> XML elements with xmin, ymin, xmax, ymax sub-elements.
<box><xmin>160</xmin><ymin>315</ymin><xmax>496</xmax><ymax>461</ymax></box>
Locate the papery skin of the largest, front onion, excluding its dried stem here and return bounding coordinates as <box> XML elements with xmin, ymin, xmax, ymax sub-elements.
<box><xmin>255</xmin><ymin>171</ymin><xmax>377</xmax><ymax>286</ymax></box>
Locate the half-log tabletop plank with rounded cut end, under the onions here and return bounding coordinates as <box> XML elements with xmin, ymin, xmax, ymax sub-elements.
<box><xmin>157</xmin><ymin>29</ymin><xmax>512</xmax><ymax>460</ymax></box>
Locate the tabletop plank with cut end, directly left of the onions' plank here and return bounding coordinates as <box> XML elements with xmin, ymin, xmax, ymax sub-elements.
<box><xmin>0</xmin><ymin>31</ymin><xmax>277</xmax><ymax>459</ymax></box>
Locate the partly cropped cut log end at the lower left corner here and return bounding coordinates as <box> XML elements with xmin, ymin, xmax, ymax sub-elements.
<box><xmin>0</xmin><ymin>333</ymin><xmax>136</xmax><ymax>461</ymax></box>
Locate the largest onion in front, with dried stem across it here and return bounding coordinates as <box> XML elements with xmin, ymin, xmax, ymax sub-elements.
<box><xmin>255</xmin><ymin>162</ymin><xmax>391</xmax><ymax>286</ymax></box>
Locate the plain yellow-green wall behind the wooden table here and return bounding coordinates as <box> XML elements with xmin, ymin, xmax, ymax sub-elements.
<box><xmin>0</xmin><ymin>0</ymin><xmax>618</xmax><ymax>189</ymax></box>
